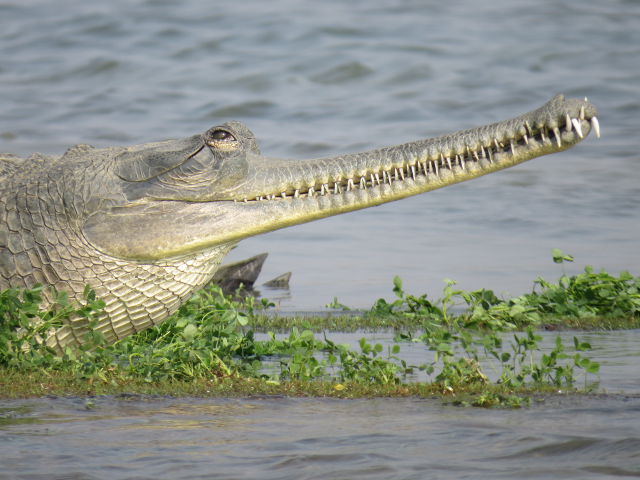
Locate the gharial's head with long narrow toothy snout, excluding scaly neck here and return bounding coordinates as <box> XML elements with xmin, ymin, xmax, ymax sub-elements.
<box><xmin>83</xmin><ymin>96</ymin><xmax>599</xmax><ymax>261</ymax></box>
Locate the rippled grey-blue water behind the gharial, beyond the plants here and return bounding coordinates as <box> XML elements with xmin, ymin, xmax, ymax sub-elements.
<box><xmin>0</xmin><ymin>0</ymin><xmax>640</xmax><ymax>311</ymax></box>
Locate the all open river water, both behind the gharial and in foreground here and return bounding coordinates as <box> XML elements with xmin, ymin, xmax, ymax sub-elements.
<box><xmin>0</xmin><ymin>0</ymin><xmax>640</xmax><ymax>479</ymax></box>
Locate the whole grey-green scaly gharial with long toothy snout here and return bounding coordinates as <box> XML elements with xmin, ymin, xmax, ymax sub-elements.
<box><xmin>0</xmin><ymin>96</ymin><xmax>599</xmax><ymax>350</ymax></box>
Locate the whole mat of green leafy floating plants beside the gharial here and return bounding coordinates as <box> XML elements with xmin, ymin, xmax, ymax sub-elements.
<box><xmin>0</xmin><ymin>251</ymin><xmax>640</xmax><ymax>407</ymax></box>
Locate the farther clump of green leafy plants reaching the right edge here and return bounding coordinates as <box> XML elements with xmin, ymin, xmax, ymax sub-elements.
<box><xmin>356</xmin><ymin>249</ymin><xmax>640</xmax><ymax>330</ymax></box>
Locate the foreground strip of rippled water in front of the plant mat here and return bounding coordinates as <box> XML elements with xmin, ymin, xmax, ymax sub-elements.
<box><xmin>0</xmin><ymin>396</ymin><xmax>640</xmax><ymax>480</ymax></box>
